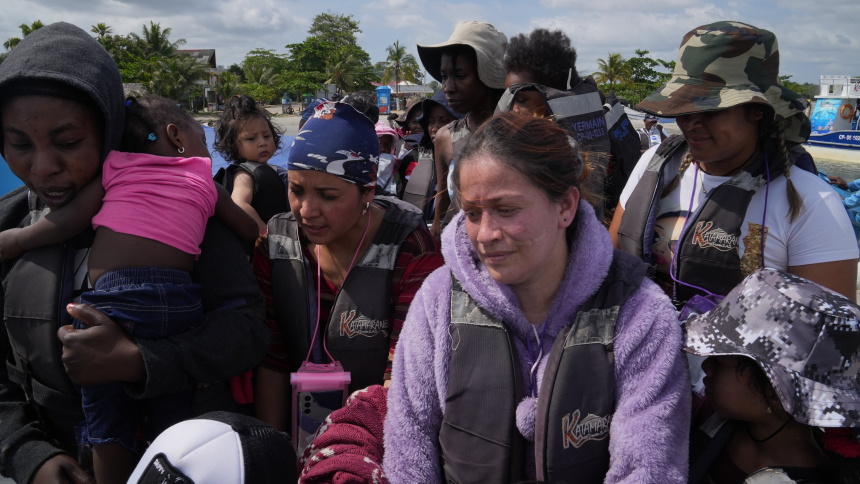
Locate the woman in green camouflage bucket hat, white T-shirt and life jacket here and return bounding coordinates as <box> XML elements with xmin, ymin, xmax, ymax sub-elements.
<box><xmin>610</xmin><ymin>21</ymin><xmax>858</xmax><ymax>306</ymax></box>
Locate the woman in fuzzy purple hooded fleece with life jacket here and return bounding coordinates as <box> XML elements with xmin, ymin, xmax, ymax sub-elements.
<box><xmin>383</xmin><ymin>114</ymin><xmax>691</xmax><ymax>484</ymax></box>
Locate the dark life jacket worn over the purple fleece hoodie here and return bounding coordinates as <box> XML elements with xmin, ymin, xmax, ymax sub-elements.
<box><xmin>439</xmin><ymin>250</ymin><xmax>647</xmax><ymax>484</ymax></box>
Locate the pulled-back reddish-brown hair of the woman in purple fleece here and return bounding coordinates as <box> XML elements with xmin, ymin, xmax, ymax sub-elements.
<box><xmin>452</xmin><ymin>113</ymin><xmax>596</xmax><ymax>241</ymax></box>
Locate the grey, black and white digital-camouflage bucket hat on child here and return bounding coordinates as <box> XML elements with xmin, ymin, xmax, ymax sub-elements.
<box><xmin>684</xmin><ymin>269</ymin><xmax>860</xmax><ymax>427</ymax></box>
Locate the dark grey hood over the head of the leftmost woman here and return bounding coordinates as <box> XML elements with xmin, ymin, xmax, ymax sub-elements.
<box><xmin>0</xmin><ymin>22</ymin><xmax>125</xmax><ymax>160</ymax></box>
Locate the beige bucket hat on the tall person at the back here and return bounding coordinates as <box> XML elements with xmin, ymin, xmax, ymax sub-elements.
<box><xmin>418</xmin><ymin>20</ymin><xmax>508</xmax><ymax>89</ymax></box>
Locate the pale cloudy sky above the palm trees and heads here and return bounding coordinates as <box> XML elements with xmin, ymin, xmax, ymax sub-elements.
<box><xmin>0</xmin><ymin>0</ymin><xmax>860</xmax><ymax>83</ymax></box>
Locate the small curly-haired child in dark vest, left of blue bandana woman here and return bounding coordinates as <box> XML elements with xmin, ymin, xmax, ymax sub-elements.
<box><xmin>215</xmin><ymin>96</ymin><xmax>290</xmax><ymax>232</ymax></box>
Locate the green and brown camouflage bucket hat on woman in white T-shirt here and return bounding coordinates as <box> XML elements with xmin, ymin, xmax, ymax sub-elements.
<box><xmin>636</xmin><ymin>21</ymin><xmax>810</xmax><ymax>143</ymax></box>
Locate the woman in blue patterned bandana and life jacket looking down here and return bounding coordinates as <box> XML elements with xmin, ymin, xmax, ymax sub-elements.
<box><xmin>254</xmin><ymin>102</ymin><xmax>442</xmax><ymax>430</ymax></box>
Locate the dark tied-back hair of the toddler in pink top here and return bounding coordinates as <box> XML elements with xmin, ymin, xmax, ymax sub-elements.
<box><xmin>119</xmin><ymin>96</ymin><xmax>197</xmax><ymax>153</ymax></box>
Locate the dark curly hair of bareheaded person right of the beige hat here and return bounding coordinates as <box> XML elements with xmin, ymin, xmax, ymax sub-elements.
<box><xmin>505</xmin><ymin>28</ymin><xmax>579</xmax><ymax>91</ymax></box>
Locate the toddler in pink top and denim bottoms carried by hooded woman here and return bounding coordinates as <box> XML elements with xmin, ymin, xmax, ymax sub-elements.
<box><xmin>0</xmin><ymin>96</ymin><xmax>258</xmax><ymax>484</ymax></box>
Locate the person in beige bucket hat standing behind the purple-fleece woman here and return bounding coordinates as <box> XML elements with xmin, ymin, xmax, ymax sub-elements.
<box><xmin>418</xmin><ymin>21</ymin><xmax>508</xmax><ymax>239</ymax></box>
